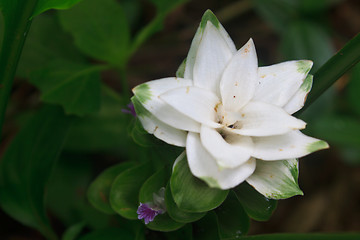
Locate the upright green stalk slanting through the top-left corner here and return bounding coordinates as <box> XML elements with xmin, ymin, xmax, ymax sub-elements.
<box><xmin>0</xmin><ymin>0</ymin><xmax>38</xmax><ymax>135</ymax></box>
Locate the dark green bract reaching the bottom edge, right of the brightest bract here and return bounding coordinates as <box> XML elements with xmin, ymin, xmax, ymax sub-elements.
<box><xmin>215</xmin><ymin>192</ymin><xmax>250</xmax><ymax>239</ymax></box>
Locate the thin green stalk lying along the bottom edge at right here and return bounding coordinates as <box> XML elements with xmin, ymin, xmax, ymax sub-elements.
<box><xmin>239</xmin><ymin>233</ymin><xmax>360</xmax><ymax>240</ymax></box>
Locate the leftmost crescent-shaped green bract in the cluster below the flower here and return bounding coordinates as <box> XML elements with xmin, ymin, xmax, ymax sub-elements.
<box><xmin>87</xmin><ymin>162</ymin><xmax>134</xmax><ymax>214</ymax></box>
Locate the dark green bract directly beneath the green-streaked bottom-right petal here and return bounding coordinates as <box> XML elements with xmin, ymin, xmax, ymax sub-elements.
<box><xmin>234</xmin><ymin>182</ymin><xmax>277</xmax><ymax>221</ymax></box>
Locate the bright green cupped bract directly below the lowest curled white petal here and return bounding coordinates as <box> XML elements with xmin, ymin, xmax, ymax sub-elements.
<box><xmin>170</xmin><ymin>152</ymin><xmax>229</xmax><ymax>212</ymax></box>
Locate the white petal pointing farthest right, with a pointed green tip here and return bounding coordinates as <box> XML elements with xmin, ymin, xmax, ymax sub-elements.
<box><xmin>252</xmin><ymin>131</ymin><xmax>329</xmax><ymax>160</ymax></box>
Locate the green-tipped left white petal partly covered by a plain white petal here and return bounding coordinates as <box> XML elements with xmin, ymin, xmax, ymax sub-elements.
<box><xmin>133</xmin><ymin>77</ymin><xmax>200</xmax><ymax>132</ymax></box>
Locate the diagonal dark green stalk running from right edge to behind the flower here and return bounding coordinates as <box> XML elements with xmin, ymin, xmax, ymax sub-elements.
<box><xmin>296</xmin><ymin>34</ymin><xmax>360</xmax><ymax>115</ymax></box>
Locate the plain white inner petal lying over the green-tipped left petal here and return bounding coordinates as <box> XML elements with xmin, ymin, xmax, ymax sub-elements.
<box><xmin>160</xmin><ymin>87</ymin><xmax>220</xmax><ymax>127</ymax></box>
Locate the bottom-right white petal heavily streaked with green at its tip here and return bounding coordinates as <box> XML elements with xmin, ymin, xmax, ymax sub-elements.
<box><xmin>246</xmin><ymin>159</ymin><xmax>303</xmax><ymax>199</ymax></box>
